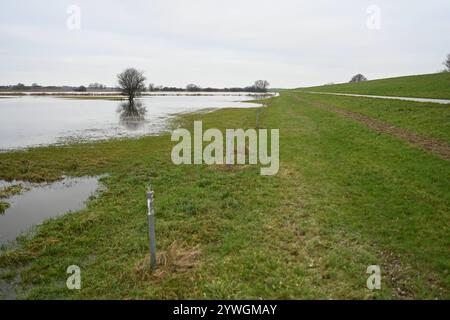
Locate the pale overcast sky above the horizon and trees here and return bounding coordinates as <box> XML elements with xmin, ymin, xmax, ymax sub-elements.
<box><xmin>0</xmin><ymin>0</ymin><xmax>450</xmax><ymax>87</ymax></box>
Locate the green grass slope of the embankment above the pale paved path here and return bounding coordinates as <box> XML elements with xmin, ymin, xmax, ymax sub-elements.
<box><xmin>300</xmin><ymin>72</ymin><xmax>450</xmax><ymax>99</ymax></box>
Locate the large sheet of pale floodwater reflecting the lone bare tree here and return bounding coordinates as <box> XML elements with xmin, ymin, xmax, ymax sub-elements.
<box><xmin>0</xmin><ymin>94</ymin><xmax>268</xmax><ymax>151</ymax></box>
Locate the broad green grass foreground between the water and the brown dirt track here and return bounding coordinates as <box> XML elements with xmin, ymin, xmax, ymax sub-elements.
<box><xmin>0</xmin><ymin>91</ymin><xmax>450</xmax><ymax>299</ymax></box>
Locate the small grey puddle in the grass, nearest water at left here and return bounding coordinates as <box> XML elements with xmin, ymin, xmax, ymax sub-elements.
<box><xmin>0</xmin><ymin>177</ymin><xmax>100</xmax><ymax>246</ymax></box>
